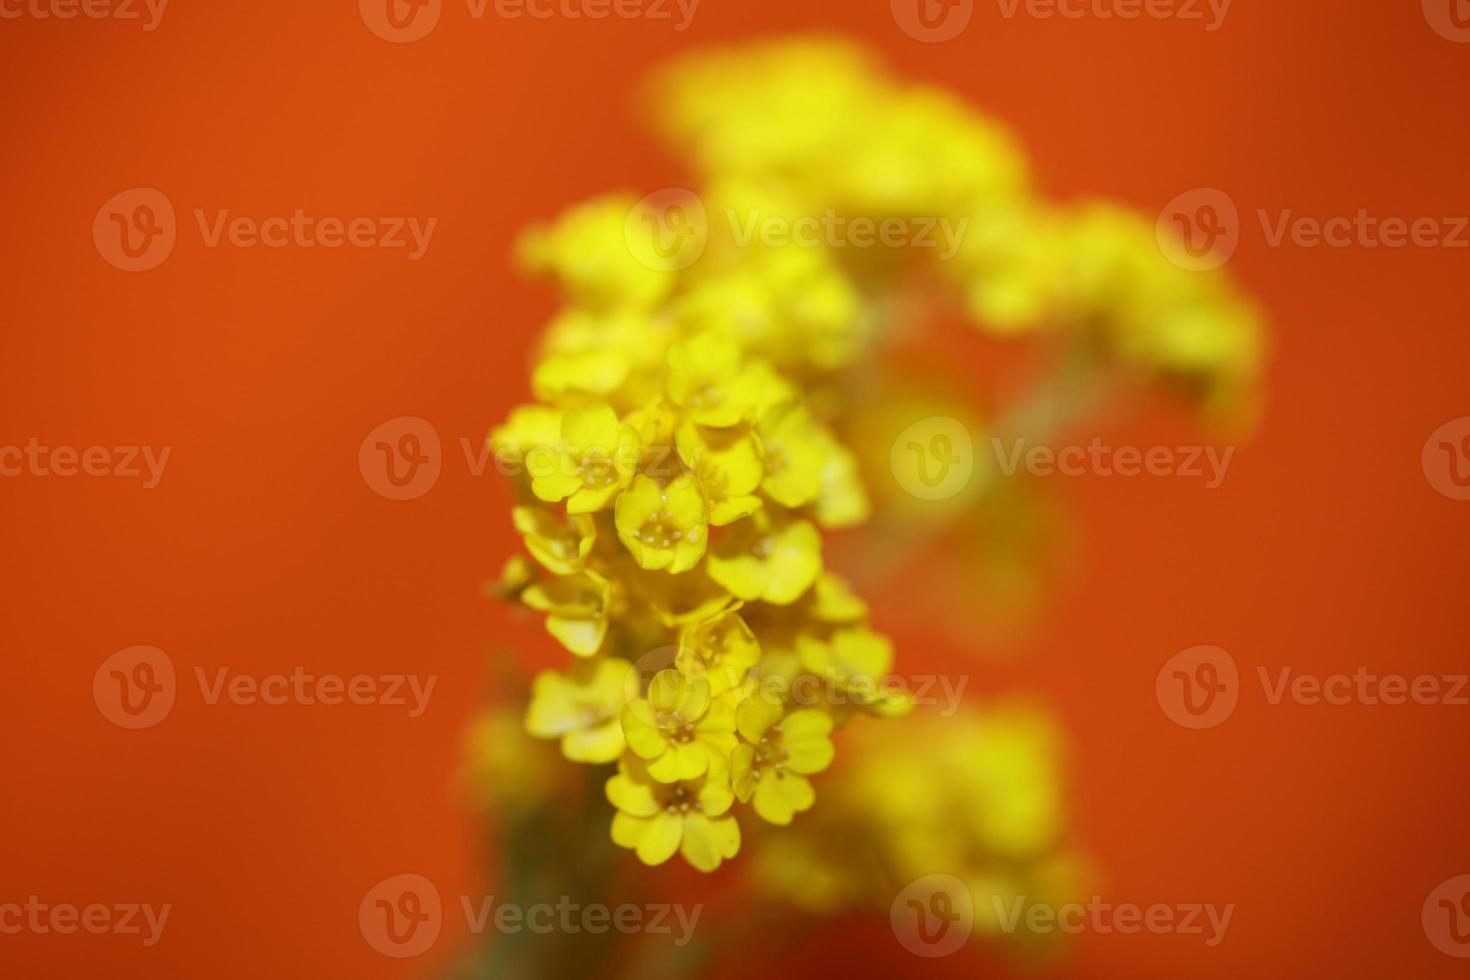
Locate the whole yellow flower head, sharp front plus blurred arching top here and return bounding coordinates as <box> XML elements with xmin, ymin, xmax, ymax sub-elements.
<box><xmin>491</xmin><ymin>40</ymin><xmax>1258</xmax><ymax>871</ymax></box>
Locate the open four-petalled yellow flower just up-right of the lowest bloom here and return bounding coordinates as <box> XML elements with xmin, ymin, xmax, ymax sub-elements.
<box><xmin>731</xmin><ymin>693</ymin><xmax>835</xmax><ymax>826</ymax></box>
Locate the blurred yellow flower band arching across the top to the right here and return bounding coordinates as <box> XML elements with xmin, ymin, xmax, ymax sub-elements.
<box><xmin>654</xmin><ymin>38</ymin><xmax>1266</xmax><ymax>413</ymax></box>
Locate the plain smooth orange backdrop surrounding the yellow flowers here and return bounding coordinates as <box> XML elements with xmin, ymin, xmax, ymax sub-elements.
<box><xmin>0</xmin><ymin>0</ymin><xmax>1470</xmax><ymax>977</ymax></box>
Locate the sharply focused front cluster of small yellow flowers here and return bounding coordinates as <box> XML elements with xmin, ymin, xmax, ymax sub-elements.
<box><xmin>491</xmin><ymin>198</ymin><xmax>907</xmax><ymax>871</ymax></box>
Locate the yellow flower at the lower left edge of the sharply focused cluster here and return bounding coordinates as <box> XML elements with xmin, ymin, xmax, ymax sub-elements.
<box><xmin>526</xmin><ymin>657</ymin><xmax>634</xmax><ymax>764</ymax></box>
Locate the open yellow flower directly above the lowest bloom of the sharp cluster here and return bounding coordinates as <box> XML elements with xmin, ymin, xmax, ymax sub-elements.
<box><xmin>622</xmin><ymin>670</ymin><xmax>735</xmax><ymax>783</ymax></box>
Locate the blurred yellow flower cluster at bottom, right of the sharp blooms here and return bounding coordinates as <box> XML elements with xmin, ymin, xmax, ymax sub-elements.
<box><xmin>754</xmin><ymin>702</ymin><xmax>1088</xmax><ymax>936</ymax></box>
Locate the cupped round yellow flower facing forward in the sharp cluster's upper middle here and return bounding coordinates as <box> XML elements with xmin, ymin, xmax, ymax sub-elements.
<box><xmin>616</xmin><ymin>473</ymin><xmax>709</xmax><ymax>574</ymax></box>
